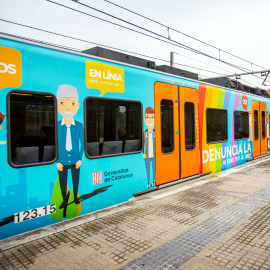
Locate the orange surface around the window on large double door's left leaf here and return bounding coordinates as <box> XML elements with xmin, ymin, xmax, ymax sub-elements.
<box><xmin>155</xmin><ymin>82</ymin><xmax>180</xmax><ymax>185</ymax></box>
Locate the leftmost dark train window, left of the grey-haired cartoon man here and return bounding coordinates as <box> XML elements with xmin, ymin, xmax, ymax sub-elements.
<box><xmin>8</xmin><ymin>91</ymin><xmax>57</xmax><ymax>167</ymax></box>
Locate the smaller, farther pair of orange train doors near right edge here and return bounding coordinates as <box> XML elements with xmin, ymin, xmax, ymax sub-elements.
<box><xmin>252</xmin><ymin>101</ymin><xmax>267</xmax><ymax>157</ymax></box>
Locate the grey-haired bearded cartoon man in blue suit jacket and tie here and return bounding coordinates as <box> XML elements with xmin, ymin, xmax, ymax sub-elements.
<box><xmin>57</xmin><ymin>84</ymin><xmax>84</xmax><ymax>209</ymax></box>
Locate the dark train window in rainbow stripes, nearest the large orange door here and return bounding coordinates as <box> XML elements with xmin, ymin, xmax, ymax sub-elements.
<box><xmin>206</xmin><ymin>108</ymin><xmax>228</xmax><ymax>143</ymax></box>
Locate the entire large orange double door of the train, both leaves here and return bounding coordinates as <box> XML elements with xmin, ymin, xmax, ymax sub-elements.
<box><xmin>155</xmin><ymin>82</ymin><xmax>199</xmax><ymax>185</ymax></box>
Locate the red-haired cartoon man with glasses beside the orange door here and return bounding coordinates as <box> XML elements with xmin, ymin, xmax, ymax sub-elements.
<box><xmin>143</xmin><ymin>107</ymin><xmax>156</xmax><ymax>188</ymax></box>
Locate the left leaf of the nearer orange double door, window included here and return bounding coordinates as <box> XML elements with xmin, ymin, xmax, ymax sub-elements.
<box><xmin>155</xmin><ymin>82</ymin><xmax>180</xmax><ymax>185</ymax></box>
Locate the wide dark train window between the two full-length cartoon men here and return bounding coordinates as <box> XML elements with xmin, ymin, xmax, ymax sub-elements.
<box><xmin>85</xmin><ymin>98</ymin><xmax>142</xmax><ymax>158</ymax></box>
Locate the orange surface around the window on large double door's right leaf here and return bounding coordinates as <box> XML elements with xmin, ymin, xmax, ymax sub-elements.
<box><xmin>180</xmin><ymin>87</ymin><xmax>200</xmax><ymax>178</ymax></box>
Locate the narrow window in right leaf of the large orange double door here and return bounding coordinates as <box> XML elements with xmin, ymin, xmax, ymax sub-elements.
<box><xmin>184</xmin><ymin>102</ymin><xmax>195</xmax><ymax>150</ymax></box>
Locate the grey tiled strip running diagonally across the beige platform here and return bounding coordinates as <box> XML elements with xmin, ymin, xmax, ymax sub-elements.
<box><xmin>122</xmin><ymin>182</ymin><xmax>270</xmax><ymax>270</ymax></box>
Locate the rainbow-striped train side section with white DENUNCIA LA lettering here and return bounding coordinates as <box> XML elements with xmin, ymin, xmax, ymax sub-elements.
<box><xmin>199</xmin><ymin>84</ymin><xmax>251</xmax><ymax>173</ymax></box>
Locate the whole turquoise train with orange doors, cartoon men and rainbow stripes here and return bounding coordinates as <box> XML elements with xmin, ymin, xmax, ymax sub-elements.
<box><xmin>0</xmin><ymin>34</ymin><xmax>270</xmax><ymax>240</ymax></box>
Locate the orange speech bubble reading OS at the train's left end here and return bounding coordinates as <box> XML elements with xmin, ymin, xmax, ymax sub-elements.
<box><xmin>0</xmin><ymin>46</ymin><xmax>22</xmax><ymax>90</ymax></box>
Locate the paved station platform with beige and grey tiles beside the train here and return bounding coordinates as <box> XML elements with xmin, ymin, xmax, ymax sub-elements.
<box><xmin>0</xmin><ymin>159</ymin><xmax>270</xmax><ymax>270</ymax></box>
